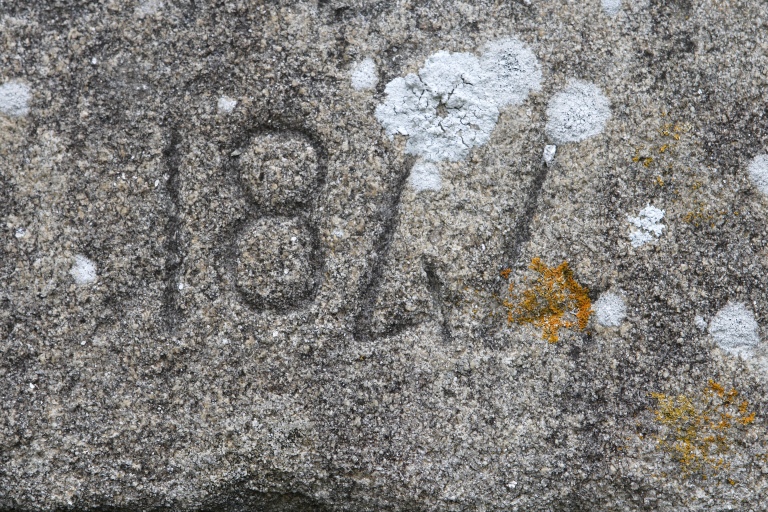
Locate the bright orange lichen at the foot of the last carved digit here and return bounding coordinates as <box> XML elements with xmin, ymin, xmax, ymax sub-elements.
<box><xmin>503</xmin><ymin>258</ymin><xmax>592</xmax><ymax>343</ymax></box>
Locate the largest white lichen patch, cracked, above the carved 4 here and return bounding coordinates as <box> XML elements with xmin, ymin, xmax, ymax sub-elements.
<box><xmin>376</xmin><ymin>39</ymin><xmax>541</xmax><ymax>162</ymax></box>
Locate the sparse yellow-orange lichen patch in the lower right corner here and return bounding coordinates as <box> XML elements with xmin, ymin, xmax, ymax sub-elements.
<box><xmin>651</xmin><ymin>380</ymin><xmax>755</xmax><ymax>478</ymax></box>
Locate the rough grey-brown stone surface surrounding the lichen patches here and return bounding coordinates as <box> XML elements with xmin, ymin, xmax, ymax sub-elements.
<box><xmin>0</xmin><ymin>0</ymin><xmax>768</xmax><ymax>511</ymax></box>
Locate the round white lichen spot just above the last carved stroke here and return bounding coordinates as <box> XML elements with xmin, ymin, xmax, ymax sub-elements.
<box><xmin>545</xmin><ymin>80</ymin><xmax>611</xmax><ymax>144</ymax></box>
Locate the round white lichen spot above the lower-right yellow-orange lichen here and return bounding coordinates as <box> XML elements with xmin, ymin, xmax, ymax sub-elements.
<box><xmin>709</xmin><ymin>301</ymin><xmax>760</xmax><ymax>355</ymax></box>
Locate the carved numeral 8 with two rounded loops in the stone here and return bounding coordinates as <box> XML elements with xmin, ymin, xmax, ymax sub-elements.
<box><xmin>235</xmin><ymin>131</ymin><xmax>323</xmax><ymax>311</ymax></box>
